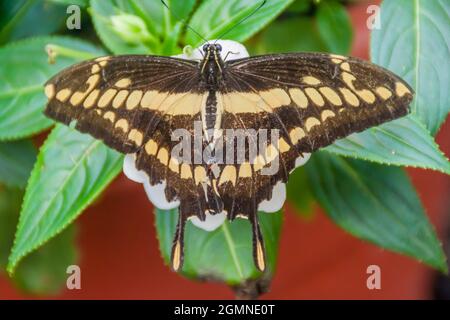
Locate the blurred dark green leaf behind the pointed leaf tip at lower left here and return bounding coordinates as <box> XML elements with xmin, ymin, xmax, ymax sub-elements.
<box><xmin>0</xmin><ymin>187</ymin><xmax>77</xmax><ymax>295</ymax></box>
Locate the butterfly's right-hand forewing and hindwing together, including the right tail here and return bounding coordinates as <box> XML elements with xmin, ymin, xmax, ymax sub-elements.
<box><xmin>218</xmin><ymin>53</ymin><xmax>413</xmax><ymax>270</ymax></box>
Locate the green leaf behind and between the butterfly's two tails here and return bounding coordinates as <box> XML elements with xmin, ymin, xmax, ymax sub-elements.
<box><xmin>156</xmin><ymin>209</ymin><xmax>282</xmax><ymax>285</ymax></box>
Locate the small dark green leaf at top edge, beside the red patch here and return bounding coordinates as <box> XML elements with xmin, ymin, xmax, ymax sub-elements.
<box><xmin>317</xmin><ymin>1</ymin><xmax>353</xmax><ymax>55</ymax></box>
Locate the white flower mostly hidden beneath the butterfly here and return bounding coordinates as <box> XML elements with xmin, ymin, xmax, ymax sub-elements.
<box><xmin>123</xmin><ymin>40</ymin><xmax>310</xmax><ymax>231</ymax></box>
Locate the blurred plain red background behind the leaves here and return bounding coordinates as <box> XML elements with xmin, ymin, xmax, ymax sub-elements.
<box><xmin>0</xmin><ymin>4</ymin><xmax>450</xmax><ymax>299</ymax></box>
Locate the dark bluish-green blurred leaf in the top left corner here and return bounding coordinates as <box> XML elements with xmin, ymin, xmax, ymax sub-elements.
<box><xmin>0</xmin><ymin>0</ymin><xmax>67</xmax><ymax>44</ymax></box>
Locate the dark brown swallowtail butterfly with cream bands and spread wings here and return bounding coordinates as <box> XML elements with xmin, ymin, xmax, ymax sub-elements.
<box><xmin>45</xmin><ymin>42</ymin><xmax>413</xmax><ymax>271</ymax></box>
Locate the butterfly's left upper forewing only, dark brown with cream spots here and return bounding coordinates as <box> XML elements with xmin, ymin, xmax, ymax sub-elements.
<box><xmin>45</xmin><ymin>55</ymin><xmax>200</xmax><ymax>153</ymax></box>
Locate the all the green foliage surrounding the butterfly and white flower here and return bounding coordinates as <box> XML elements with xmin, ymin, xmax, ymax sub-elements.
<box><xmin>0</xmin><ymin>0</ymin><xmax>450</xmax><ymax>293</ymax></box>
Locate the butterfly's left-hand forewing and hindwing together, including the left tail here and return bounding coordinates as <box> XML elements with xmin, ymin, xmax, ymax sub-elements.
<box><xmin>45</xmin><ymin>55</ymin><xmax>207</xmax><ymax>269</ymax></box>
